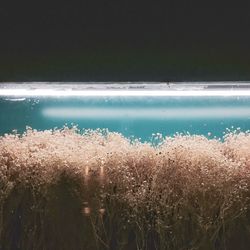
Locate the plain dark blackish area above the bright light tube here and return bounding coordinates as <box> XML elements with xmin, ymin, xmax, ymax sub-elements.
<box><xmin>0</xmin><ymin>0</ymin><xmax>250</xmax><ymax>81</ymax></box>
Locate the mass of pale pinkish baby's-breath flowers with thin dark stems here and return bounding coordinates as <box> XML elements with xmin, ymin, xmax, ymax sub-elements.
<box><xmin>0</xmin><ymin>128</ymin><xmax>250</xmax><ymax>250</ymax></box>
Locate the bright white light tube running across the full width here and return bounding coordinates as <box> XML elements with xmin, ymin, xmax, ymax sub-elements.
<box><xmin>0</xmin><ymin>88</ymin><xmax>250</xmax><ymax>97</ymax></box>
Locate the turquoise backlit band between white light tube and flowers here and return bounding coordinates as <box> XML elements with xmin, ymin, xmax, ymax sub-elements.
<box><xmin>0</xmin><ymin>84</ymin><xmax>250</xmax><ymax>141</ymax></box>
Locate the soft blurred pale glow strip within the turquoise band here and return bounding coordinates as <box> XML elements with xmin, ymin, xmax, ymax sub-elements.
<box><xmin>43</xmin><ymin>107</ymin><xmax>250</xmax><ymax>120</ymax></box>
